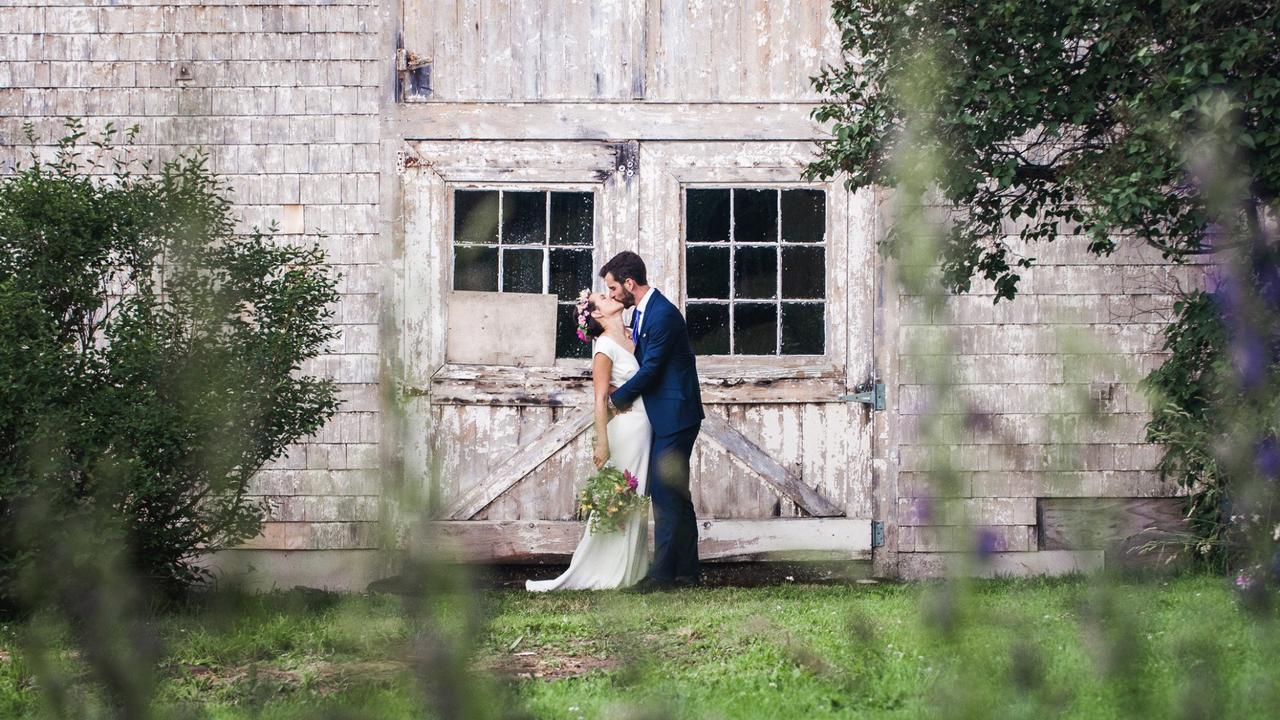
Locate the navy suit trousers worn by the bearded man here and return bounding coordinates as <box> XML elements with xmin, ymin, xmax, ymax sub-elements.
<box><xmin>649</xmin><ymin>425</ymin><xmax>698</xmax><ymax>580</ymax></box>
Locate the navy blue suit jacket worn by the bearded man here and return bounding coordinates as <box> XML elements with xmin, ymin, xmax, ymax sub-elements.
<box><xmin>611</xmin><ymin>290</ymin><xmax>704</xmax><ymax>437</ymax></box>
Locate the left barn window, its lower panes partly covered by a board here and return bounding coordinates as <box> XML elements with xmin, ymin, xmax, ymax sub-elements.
<box><xmin>453</xmin><ymin>190</ymin><xmax>595</xmax><ymax>357</ymax></box>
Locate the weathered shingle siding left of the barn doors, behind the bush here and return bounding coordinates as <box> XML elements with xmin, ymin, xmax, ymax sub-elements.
<box><xmin>0</xmin><ymin>0</ymin><xmax>388</xmax><ymax>550</ymax></box>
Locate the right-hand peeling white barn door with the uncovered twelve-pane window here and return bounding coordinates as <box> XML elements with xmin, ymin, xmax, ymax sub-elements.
<box><xmin>640</xmin><ymin>142</ymin><xmax>872</xmax><ymax>551</ymax></box>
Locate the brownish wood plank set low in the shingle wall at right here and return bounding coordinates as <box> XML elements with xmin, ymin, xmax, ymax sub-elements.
<box><xmin>1037</xmin><ymin>497</ymin><xmax>1187</xmax><ymax>565</ymax></box>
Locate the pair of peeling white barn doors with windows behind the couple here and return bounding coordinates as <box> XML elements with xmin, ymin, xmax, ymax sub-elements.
<box><xmin>403</xmin><ymin>141</ymin><xmax>870</xmax><ymax>561</ymax></box>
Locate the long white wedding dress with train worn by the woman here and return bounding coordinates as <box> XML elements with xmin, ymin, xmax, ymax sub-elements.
<box><xmin>525</xmin><ymin>336</ymin><xmax>653</xmax><ymax>592</ymax></box>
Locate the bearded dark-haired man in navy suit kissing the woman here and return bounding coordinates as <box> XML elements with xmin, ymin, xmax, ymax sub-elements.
<box><xmin>600</xmin><ymin>251</ymin><xmax>704</xmax><ymax>592</ymax></box>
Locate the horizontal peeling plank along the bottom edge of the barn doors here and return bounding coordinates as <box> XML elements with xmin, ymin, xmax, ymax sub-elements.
<box><xmin>431</xmin><ymin>518</ymin><xmax>870</xmax><ymax>562</ymax></box>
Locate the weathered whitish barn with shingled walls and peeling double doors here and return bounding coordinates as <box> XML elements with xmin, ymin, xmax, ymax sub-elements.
<box><xmin>0</xmin><ymin>0</ymin><xmax>1196</xmax><ymax>588</ymax></box>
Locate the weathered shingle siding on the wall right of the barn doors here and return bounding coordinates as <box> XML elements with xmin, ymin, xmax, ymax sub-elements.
<box><xmin>895</xmin><ymin>237</ymin><xmax>1206</xmax><ymax>577</ymax></box>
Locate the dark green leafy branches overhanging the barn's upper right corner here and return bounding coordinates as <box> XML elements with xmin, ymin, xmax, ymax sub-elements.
<box><xmin>812</xmin><ymin>0</ymin><xmax>1280</xmax><ymax>301</ymax></box>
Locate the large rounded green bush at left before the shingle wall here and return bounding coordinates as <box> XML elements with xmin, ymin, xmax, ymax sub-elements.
<box><xmin>0</xmin><ymin>120</ymin><xmax>338</xmax><ymax>602</ymax></box>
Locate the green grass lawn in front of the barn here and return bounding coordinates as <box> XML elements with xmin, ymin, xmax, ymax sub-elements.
<box><xmin>0</xmin><ymin>575</ymin><xmax>1280</xmax><ymax>719</ymax></box>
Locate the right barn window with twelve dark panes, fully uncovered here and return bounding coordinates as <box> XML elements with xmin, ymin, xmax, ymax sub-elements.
<box><xmin>685</xmin><ymin>188</ymin><xmax>827</xmax><ymax>355</ymax></box>
